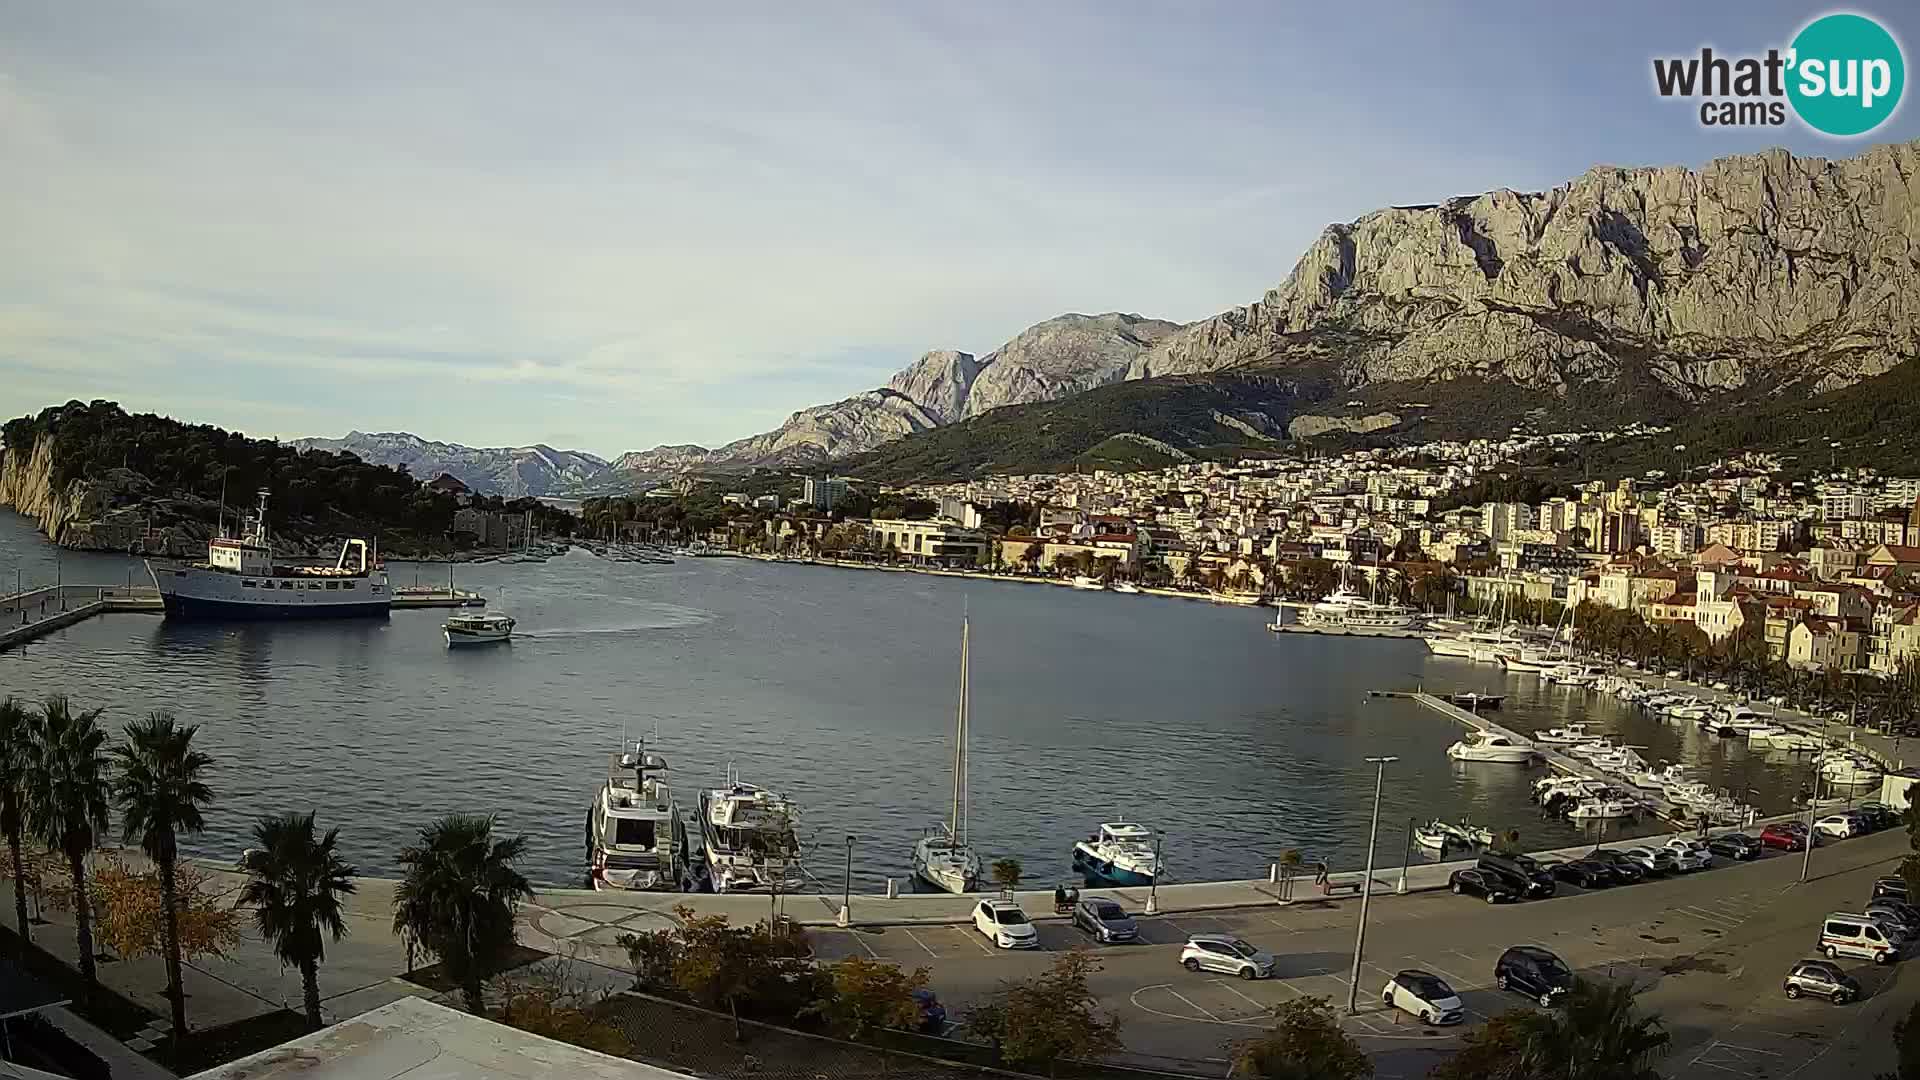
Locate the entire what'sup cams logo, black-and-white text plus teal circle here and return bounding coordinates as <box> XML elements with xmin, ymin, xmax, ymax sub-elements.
<box><xmin>1653</xmin><ymin>12</ymin><xmax>1907</xmax><ymax>138</ymax></box>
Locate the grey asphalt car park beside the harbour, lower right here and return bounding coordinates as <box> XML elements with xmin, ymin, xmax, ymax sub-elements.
<box><xmin>791</xmin><ymin>830</ymin><xmax>1920</xmax><ymax>1080</ymax></box>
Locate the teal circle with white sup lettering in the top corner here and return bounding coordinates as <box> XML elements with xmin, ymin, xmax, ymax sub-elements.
<box><xmin>1788</xmin><ymin>13</ymin><xmax>1907</xmax><ymax>136</ymax></box>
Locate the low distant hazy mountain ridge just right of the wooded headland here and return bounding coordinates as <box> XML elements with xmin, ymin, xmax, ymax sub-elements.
<box><xmin>292</xmin><ymin>430</ymin><xmax>607</xmax><ymax>498</ymax></box>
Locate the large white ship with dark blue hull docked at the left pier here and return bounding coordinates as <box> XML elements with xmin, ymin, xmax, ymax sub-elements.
<box><xmin>146</xmin><ymin>492</ymin><xmax>394</xmax><ymax>619</ymax></box>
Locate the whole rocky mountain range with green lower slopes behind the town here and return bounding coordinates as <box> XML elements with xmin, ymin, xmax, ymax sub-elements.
<box><xmin>321</xmin><ymin>142</ymin><xmax>1920</xmax><ymax>494</ymax></box>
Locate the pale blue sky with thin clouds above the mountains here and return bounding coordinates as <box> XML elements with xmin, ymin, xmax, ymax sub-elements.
<box><xmin>0</xmin><ymin>0</ymin><xmax>1920</xmax><ymax>457</ymax></box>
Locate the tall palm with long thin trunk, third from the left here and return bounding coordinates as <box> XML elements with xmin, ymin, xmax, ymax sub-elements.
<box><xmin>113</xmin><ymin>713</ymin><xmax>213</xmax><ymax>1045</ymax></box>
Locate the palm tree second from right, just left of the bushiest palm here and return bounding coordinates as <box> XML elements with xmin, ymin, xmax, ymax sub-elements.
<box><xmin>236</xmin><ymin>813</ymin><xmax>353</xmax><ymax>1030</ymax></box>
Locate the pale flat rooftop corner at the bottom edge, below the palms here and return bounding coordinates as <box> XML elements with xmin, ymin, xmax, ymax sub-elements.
<box><xmin>192</xmin><ymin>997</ymin><xmax>691</xmax><ymax>1080</ymax></box>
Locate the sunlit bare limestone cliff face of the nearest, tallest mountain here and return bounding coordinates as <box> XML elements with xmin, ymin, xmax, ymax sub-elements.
<box><xmin>1127</xmin><ymin>142</ymin><xmax>1920</xmax><ymax>400</ymax></box>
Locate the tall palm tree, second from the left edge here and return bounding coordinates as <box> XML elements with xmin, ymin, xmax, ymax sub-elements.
<box><xmin>21</xmin><ymin>696</ymin><xmax>108</xmax><ymax>1003</ymax></box>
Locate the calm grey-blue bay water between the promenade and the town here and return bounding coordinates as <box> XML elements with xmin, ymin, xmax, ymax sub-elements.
<box><xmin>0</xmin><ymin>511</ymin><xmax>1799</xmax><ymax>892</ymax></box>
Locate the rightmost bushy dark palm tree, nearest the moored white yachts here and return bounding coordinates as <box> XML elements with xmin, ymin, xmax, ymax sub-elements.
<box><xmin>394</xmin><ymin>815</ymin><xmax>534</xmax><ymax>1017</ymax></box>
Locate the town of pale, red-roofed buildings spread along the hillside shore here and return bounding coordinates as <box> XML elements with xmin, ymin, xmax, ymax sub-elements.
<box><xmin>691</xmin><ymin>432</ymin><xmax>1920</xmax><ymax>675</ymax></box>
